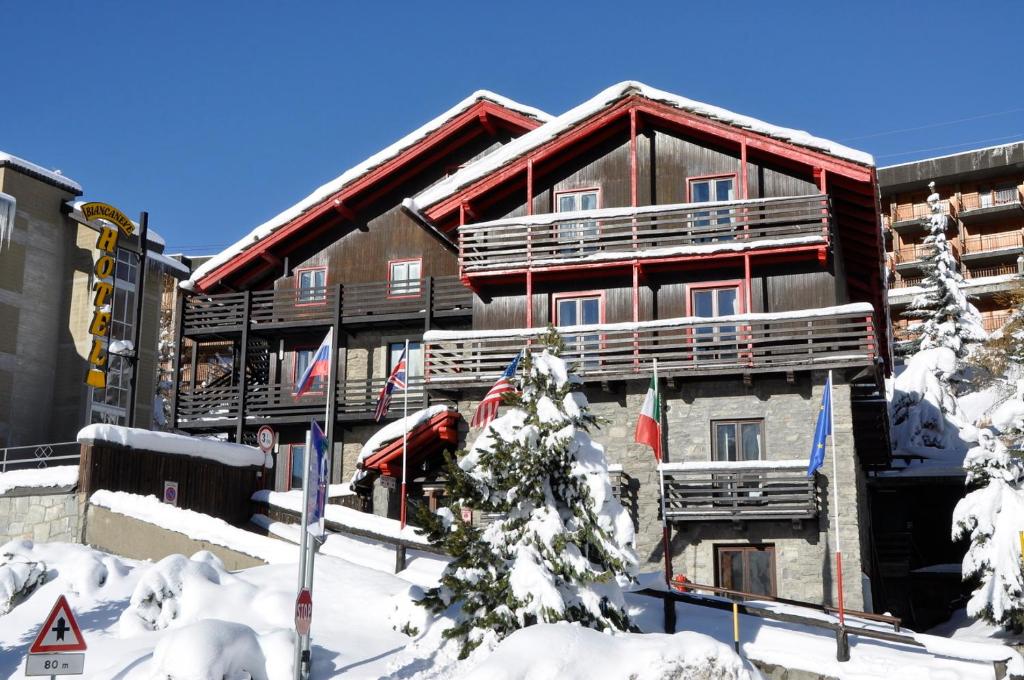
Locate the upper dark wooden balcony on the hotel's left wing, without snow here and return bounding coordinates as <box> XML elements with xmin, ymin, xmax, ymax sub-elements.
<box><xmin>182</xmin><ymin>277</ymin><xmax>473</xmax><ymax>337</ymax></box>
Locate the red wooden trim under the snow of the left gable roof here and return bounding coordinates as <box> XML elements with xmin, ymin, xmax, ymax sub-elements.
<box><xmin>196</xmin><ymin>99</ymin><xmax>541</xmax><ymax>292</ymax></box>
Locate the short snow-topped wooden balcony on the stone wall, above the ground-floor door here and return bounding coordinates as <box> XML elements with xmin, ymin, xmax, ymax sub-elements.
<box><xmin>662</xmin><ymin>460</ymin><xmax>818</xmax><ymax>521</ymax></box>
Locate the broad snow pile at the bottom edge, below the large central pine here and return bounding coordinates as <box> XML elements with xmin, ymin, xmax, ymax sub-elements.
<box><xmin>459</xmin><ymin>624</ymin><xmax>760</xmax><ymax>680</ymax></box>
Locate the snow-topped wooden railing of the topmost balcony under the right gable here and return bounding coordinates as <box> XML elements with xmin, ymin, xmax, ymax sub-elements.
<box><xmin>459</xmin><ymin>195</ymin><xmax>831</xmax><ymax>274</ymax></box>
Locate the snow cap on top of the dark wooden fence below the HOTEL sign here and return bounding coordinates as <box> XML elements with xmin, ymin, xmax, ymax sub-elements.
<box><xmin>78</xmin><ymin>423</ymin><xmax>273</xmax><ymax>468</ymax></box>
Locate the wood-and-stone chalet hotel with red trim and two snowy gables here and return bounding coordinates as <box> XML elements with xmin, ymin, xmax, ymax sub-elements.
<box><xmin>175</xmin><ymin>82</ymin><xmax>890</xmax><ymax>607</ymax></box>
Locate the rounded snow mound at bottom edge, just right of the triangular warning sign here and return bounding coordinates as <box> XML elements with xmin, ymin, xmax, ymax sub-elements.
<box><xmin>153</xmin><ymin>618</ymin><xmax>270</xmax><ymax>680</ymax></box>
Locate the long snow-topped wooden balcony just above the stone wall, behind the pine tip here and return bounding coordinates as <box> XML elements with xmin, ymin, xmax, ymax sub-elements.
<box><xmin>424</xmin><ymin>303</ymin><xmax>879</xmax><ymax>389</ymax></box>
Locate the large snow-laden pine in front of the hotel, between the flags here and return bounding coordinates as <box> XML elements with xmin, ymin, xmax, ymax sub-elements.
<box><xmin>411</xmin><ymin>328</ymin><xmax>636</xmax><ymax>657</ymax></box>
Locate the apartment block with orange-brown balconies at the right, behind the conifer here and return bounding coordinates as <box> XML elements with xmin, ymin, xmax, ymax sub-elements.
<box><xmin>879</xmin><ymin>141</ymin><xmax>1024</xmax><ymax>339</ymax></box>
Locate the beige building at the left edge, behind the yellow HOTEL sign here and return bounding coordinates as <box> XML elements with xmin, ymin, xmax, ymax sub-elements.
<box><xmin>0</xmin><ymin>153</ymin><xmax>188</xmax><ymax>450</ymax></box>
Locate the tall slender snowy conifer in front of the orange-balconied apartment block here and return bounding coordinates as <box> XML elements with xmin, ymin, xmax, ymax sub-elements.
<box><xmin>901</xmin><ymin>181</ymin><xmax>987</xmax><ymax>358</ymax></box>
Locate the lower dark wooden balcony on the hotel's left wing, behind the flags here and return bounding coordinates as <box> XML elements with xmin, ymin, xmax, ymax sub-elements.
<box><xmin>177</xmin><ymin>377</ymin><xmax>425</xmax><ymax>430</ymax></box>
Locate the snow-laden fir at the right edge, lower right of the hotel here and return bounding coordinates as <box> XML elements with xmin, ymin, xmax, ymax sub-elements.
<box><xmin>952</xmin><ymin>429</ymin><xmax>1024</xmax><ymax>633</ymax></box>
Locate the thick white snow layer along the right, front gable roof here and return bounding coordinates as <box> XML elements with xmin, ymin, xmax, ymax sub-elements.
<box><xmin>414</xmin><ymin>80</ymin><xmax>874</xmax><ymax>208</ymax></box>
